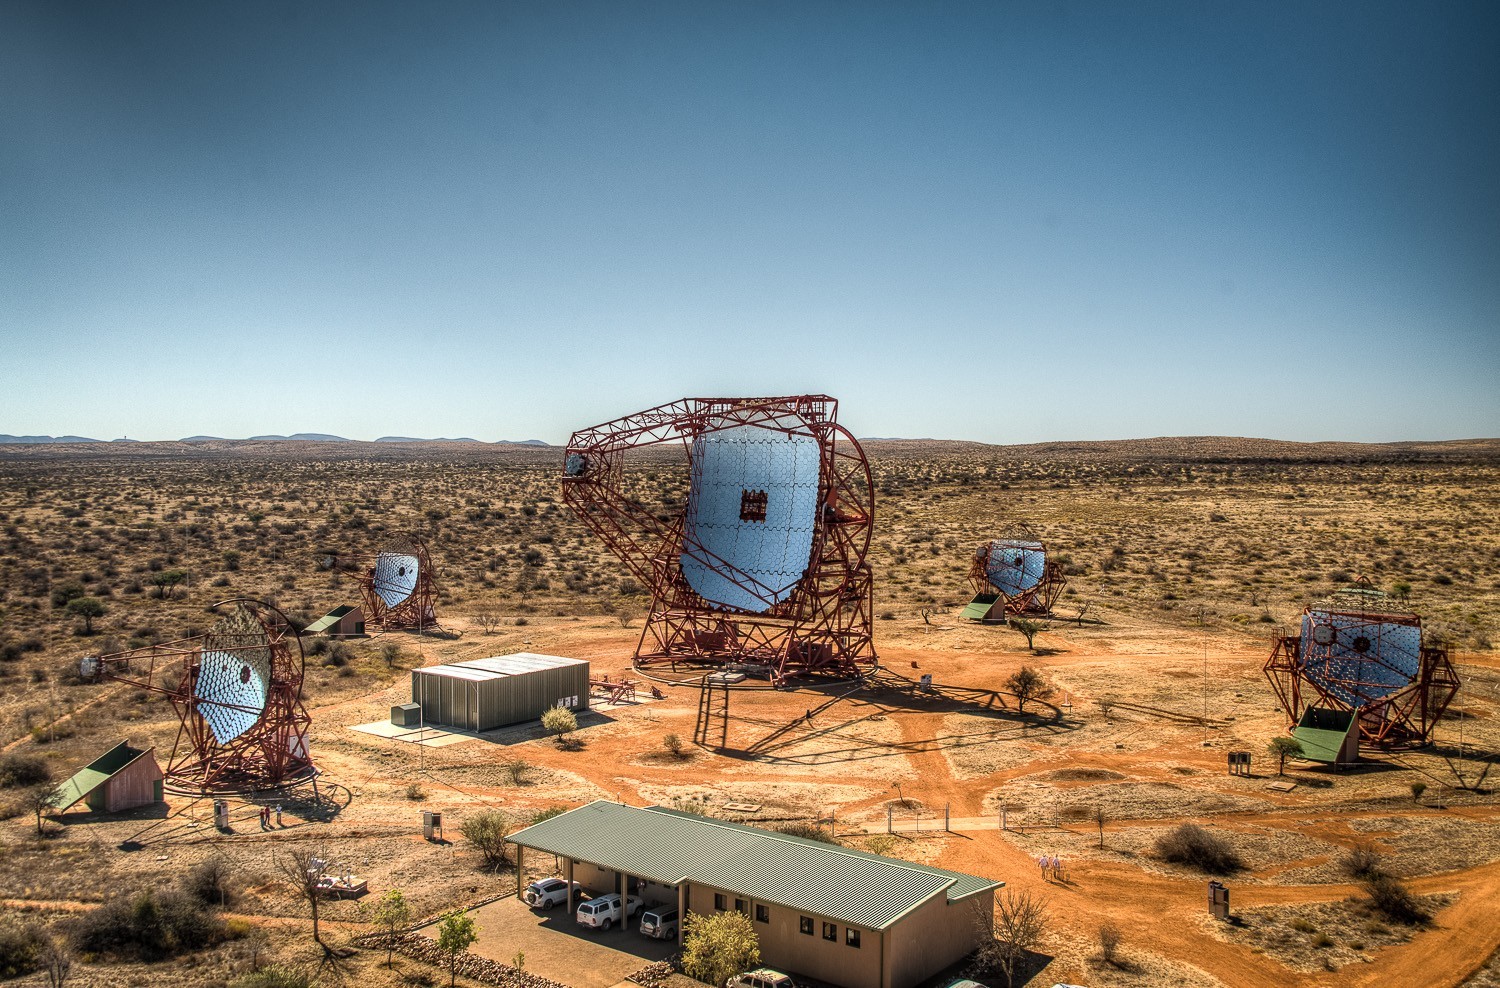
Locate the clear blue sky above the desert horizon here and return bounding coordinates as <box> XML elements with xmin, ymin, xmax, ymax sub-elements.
<box><xmin>0</xmin><ymin>0</ymin><xmax>1500</xmax><ymax>442</ymax></box>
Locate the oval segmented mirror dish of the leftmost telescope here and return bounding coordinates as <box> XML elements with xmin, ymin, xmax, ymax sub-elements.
<box><xmin>194</xmin><ymin>609</ymin><xmax>272</xmax><ymax>744</ymax></box>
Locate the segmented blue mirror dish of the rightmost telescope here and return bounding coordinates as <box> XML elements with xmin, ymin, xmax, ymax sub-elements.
<box><xmin>1301</xmin><ymin>610</ymin><xmax>1422</xmax><ymax>706</ymax></box>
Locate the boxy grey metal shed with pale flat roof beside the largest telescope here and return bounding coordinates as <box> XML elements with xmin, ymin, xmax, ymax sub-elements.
<box><xmin>411</xmin><ymin>652</ymin><xmax>588</xmax><ymax>730</ymax></box>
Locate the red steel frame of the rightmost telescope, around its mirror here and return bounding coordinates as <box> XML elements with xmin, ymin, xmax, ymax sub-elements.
<box><xmin>1263</xmin><ymin>607</ymin><xmax>1460</xmax><ymax>747</ymax></box>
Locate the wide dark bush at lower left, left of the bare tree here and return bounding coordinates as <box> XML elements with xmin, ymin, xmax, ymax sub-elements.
<box><xmin>71</xmin><ymin>891</ymin><xmax>228</xmax><ymax>961</ymax></box>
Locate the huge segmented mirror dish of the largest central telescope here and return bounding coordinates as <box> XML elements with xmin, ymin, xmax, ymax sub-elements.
<box><xmin>680</xmin><ymin>420</ymin><xmax>822</xmax><ymax>613</ymax></box>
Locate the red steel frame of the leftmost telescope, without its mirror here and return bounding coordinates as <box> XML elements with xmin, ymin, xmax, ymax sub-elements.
<box><xmin>81</xmin><ymin>598</ymin><xmax>314</xmax><ymax>792</ymax></box>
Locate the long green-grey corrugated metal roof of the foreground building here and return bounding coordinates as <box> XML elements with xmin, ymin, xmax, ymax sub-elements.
<box><xmin>507</xmin><ymin>801</ymin><xmax>1005</xmax><ymax>930</ymax></box>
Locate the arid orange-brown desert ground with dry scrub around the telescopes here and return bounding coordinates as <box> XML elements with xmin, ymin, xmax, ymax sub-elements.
<box><xmin>0</xmin><ymin>439</ymin><xmax>1500</xmax><ymax>987</ymax></box>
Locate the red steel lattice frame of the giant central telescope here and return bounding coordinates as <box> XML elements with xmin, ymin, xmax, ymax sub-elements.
<box><xmin>563</xmin><ymin>394</ymin><xmax>876</xmax><ymax>681</ymax></box>
